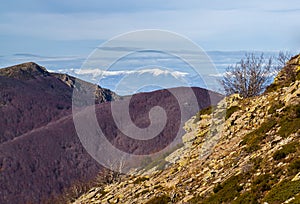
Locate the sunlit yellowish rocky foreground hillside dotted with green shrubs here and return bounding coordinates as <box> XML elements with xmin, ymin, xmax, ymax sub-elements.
<box><xmin>73</xmin><ymin>55</ymin><xmax>300</xmax><ymax>204</ymax></box>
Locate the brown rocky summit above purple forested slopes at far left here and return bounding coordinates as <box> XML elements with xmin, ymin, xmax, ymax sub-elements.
<box><xmin>0</xmin><ymin>62</ymin><xmax>49</xmax><ymax>80</ymax></box>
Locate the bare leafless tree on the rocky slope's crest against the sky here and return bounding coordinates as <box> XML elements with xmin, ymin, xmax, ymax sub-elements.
<box><xmin>221</xmin><ymin>53</ymin><xmax>272</xmax><ymax>97</ymax></box>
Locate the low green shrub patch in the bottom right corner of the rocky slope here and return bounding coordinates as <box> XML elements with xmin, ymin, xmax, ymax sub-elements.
<box><xmin>264</xmin><ymin>180</ymin><xmax>300</xmax><ymax>204</ymax></box>
